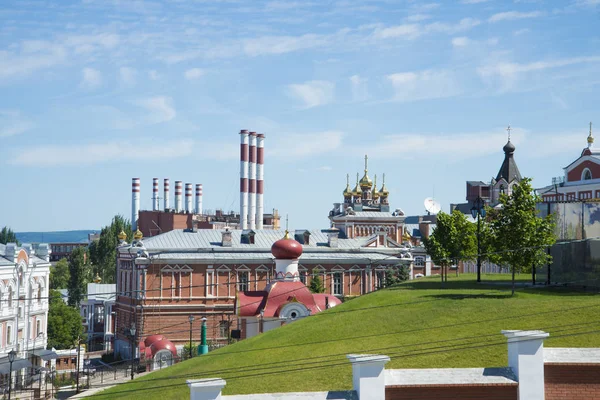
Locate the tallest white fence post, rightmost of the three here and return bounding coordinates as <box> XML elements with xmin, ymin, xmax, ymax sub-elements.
<box><xmin>502</xmin><ymin>331</ymin><xmax>550</xmax><ymax>400</ymax></box>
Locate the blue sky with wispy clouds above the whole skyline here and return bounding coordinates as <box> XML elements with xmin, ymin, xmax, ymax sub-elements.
<box><xmin>0</xmin><ymin>0</ymin><xmax>600</xmax><ymax>231</ymax></box>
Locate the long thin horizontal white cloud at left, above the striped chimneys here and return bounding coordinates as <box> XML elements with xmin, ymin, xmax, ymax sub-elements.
<box><xmin>9</xmin><ymin>140</ymin><xmax>194</xmax><ymax>166</ymax></box>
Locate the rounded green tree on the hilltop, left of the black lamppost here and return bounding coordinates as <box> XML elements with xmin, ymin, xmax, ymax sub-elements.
<box><xmin>423</xmin><ymin>210</ymin><xmax>477</xmax><ymax>282</ymax></box>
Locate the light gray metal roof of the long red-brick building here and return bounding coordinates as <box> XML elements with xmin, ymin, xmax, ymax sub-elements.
<box><xmin>143</xmin><ymin>229</ymin><xmax>369</xmax><ymax>251</ymax></box>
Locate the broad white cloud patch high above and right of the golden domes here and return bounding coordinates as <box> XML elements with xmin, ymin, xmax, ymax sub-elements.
<box><xmin>387</xmin><ymin>70</ymin><xmax>461</xmax><ymax>102</ymax></box>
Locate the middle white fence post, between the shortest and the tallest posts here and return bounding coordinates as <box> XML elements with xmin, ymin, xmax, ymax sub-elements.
<box><xmin>346</xmin><ymin>354</ymin><xmax>390</xmax><ymax>400</ymax></box>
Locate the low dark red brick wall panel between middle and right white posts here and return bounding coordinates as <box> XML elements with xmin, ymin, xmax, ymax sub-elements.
<box><xmin>385</xmin><ymin>384</ymin><xmax>517</xmax><ymax>400</ymax></box>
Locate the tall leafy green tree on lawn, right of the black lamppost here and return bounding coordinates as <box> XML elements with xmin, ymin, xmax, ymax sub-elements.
<box><xmin>491</xmin><ymin>178</ymin><xmax>556</xmax><ymax>295</ymax></box>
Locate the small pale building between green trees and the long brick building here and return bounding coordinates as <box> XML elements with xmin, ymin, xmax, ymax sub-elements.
<box><xmin>79</xmin><ymin>283</ymin><xmax>117</xmax><ymax>351</ymax></box>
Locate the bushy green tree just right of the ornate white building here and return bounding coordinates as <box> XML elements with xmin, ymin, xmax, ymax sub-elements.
<box><xmin>48</xmin><ymin>290</ymin><xmax>84</xmax><ymax>350</ymax></box>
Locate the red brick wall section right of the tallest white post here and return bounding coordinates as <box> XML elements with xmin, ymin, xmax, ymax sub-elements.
<box><xmin>544</xmin><ymin>364</ymin><xmax>600</xmax><ymax>400</ymax></box>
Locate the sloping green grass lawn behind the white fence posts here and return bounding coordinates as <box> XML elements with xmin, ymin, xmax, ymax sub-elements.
<box><xmin>90</xmin><ymin>274</ymin><xmax>600</xmax><ymax>400</ymax></box>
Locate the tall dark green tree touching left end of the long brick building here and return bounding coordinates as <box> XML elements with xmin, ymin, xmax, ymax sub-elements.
<box><xmin>89</xmin><ymin>215</ymin><xmax>133</xmax><ymax>283</ymax></box>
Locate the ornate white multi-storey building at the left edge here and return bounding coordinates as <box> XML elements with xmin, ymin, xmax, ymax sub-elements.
<box><xmin>0</xmin><ymin>243</ymin><xmax>54</xmax><ymax>382</ymax></box>
